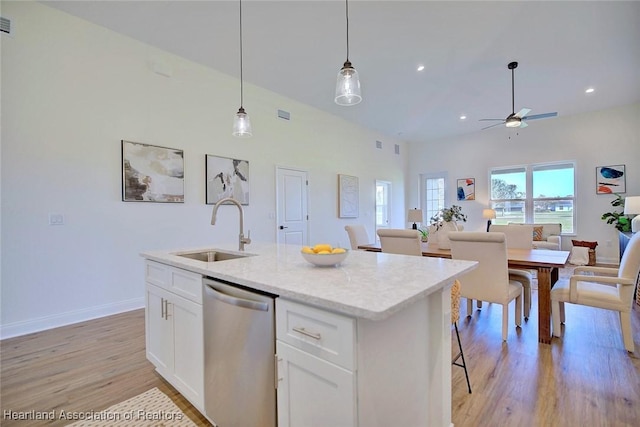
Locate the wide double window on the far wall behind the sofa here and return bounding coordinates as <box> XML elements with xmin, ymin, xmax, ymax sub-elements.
<box><xmin>490</xmin><ymin>162</ymin><xmax>575</xmax><ymax>234</ymax></box>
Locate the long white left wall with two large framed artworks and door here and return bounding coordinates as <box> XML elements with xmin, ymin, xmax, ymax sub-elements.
<box><xmin>0</xmin><ymin>2</ymin><xmax>408</xmax><ymax>338</ymax></box>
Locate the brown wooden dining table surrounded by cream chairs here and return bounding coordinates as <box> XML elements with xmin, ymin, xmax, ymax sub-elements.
<box><xmin>358</xmin><ymin>242</ymin><xmax>569</xmax><ymax>344</ymax></box>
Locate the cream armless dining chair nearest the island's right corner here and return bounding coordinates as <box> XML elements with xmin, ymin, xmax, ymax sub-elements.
<box><xmin>449</xmin><ymin>231</ymin><xmax>522</xmax><ymax>341</ymax></box>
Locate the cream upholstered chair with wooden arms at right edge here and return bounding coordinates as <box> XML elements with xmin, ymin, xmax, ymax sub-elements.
<box><xmin>551</xmin><ymin>233</ymin><xmax>640</xmax><ymax>353</ymax></box>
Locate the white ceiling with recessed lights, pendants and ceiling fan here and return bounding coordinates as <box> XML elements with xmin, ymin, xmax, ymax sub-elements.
<box><xmin>40</xmin><ymin>0</ymin><xmax>640</xmax><ymax>141</ymax></box>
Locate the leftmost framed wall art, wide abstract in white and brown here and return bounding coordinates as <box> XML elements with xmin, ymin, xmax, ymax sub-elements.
<box><xmin>121</xmin><ymin>140</ymin><xmax>184</xmax><ymax>203</ymax></box>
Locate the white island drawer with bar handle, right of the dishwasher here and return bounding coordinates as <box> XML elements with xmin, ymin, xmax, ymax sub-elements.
<box><xmin>276</xmin><ymin>298</ymin><xmax>355</xmax><ymax>370</ymax></box>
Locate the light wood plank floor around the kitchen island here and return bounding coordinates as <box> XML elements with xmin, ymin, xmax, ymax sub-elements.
<box><xmin>0</xmin><ymin>291</ymin><xmax>640</xmax><ymax>427</ymax></box>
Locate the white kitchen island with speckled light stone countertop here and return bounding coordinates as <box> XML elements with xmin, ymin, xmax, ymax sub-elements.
<box><xmin>142</xmin><ymin>243</ymin><xmax>476</xmax><ymax>427</ymax></box>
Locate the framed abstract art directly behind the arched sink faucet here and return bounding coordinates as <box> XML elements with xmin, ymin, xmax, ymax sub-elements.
<box><xmin>205</xmin><ymin>154</ymin><xmax>249</xmax><ymax>205</ymax></box>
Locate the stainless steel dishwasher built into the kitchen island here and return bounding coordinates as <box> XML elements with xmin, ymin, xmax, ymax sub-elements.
<box><xmin>203</xmin><ymin>279</ymin><xmax>276</xmax><ymax>427</ymax></box>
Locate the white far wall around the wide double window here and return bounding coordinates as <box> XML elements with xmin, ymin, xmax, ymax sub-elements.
<box><xmin>408</xmin><ymin>103</ymin><xmax>640</xmax><ymax>263</ymax></box>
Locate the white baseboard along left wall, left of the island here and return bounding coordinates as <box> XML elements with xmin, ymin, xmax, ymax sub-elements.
<box><xmin>0</xmin><ymin>298</ymin><xmax>144</xmax><ymax>339</ymax></box>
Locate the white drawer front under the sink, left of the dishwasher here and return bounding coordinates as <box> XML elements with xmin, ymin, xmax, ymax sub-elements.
<box><xmin>145</xmin><ymin>261</ymin><xmax>202</xmax><ymax>304</ymax></box>
